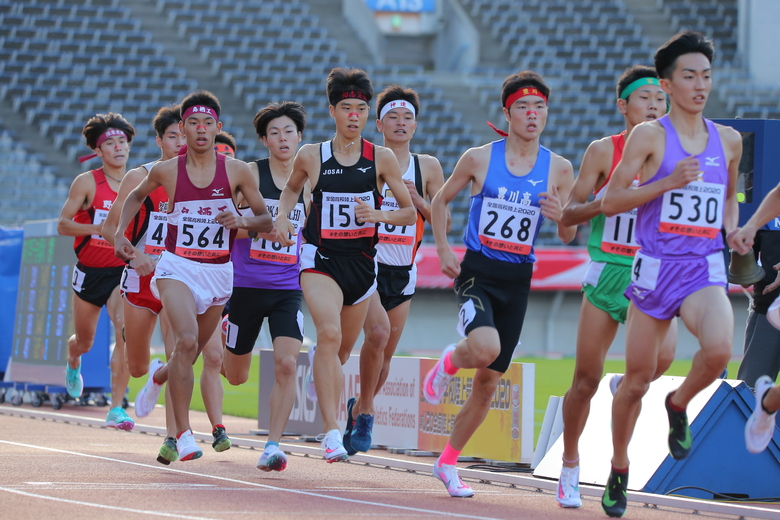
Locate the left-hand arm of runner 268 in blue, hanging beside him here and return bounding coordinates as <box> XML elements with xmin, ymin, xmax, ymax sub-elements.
<box><xmin>431</xmin><ymin>146</ymin><xmax>490</xmax><ymax>278</ymax></box>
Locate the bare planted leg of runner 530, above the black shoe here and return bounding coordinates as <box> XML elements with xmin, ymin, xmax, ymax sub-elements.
<box><xmin>612</xmin><ymin>302</ymin><xmax>670</xmax><ymax>469</ymax></box>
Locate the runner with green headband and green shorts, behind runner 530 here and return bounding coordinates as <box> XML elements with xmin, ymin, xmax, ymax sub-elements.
<box><xmin>556</xmin><ymin>65</ymin><xmax>677</xmax><ymax>507</ymax></box>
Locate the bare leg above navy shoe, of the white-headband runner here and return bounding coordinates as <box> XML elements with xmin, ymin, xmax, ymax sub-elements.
<box><xmin>352</xmin><ymin>291</ymin><xmax>390</xmax><ymax>417</ymax></box>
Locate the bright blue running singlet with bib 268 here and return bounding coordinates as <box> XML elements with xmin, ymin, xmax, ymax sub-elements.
<box><xmin>463</xmin><ymin>139</ymin><xmax>550</xmax><ymax>264</ymax></box>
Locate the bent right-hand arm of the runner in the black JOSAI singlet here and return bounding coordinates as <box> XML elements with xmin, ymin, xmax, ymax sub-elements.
<box><xmin>355</xmin><ymin>146</ymin><xmax>417</xmax><ymax>226</ymax></box>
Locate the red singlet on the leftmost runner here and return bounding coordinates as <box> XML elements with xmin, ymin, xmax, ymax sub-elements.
<box><xmin>73</xmin><ymin>168</ymin><xmax>125</xmax><ymax>267</ymax></box>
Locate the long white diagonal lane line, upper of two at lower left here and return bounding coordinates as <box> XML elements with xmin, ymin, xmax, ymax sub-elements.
<box><xmin>0</xmin><ymin>439</ymin><xmax>494</xmax><ymax>520</ymax></box>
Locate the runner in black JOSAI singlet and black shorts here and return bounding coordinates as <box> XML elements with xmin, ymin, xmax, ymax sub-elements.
<box><xmin>276</xmin><ymin>68</ymin><xmax>416</xmax><ymax>462</ymax></box>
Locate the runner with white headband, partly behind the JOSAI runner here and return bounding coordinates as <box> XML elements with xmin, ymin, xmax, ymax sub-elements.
<box><xmin>344</xmin><ymin>85</ymin><xmax>444</xmax><ymax>455</ymax></box>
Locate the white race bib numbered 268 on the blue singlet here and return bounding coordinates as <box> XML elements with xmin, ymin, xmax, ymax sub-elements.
<box><xmin>479</xmin><ymin>198</ymin><xmax>541</xmax><ymax>255</ymax></box>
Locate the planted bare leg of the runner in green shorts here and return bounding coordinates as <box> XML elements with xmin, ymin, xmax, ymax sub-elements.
<box><xmin>563</xmin><ymin>295</ymin><xmax>618</xmax><ymax>468</ymax></box>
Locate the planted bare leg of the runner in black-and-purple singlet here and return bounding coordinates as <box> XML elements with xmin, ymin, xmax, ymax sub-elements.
<box><xmin>268</xmin><ymin>336</ymin><xmax>304</xmax><ymax>442</ymax></box>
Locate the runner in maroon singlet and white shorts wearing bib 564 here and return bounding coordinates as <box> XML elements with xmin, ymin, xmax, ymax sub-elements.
<box><xmin>115</xmin><ymin>91</ymin><xmax>272</xmax><ymax>461</ymax></box>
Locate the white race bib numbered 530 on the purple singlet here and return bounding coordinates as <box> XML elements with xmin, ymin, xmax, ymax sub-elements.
<box><xmin>659</xmin><ymin>181</ymin><xmax>726</xmax><ymax>238</ymax></box>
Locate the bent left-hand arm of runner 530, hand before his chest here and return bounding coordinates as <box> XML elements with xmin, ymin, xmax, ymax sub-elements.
<box><xmin>601</xmin><ymin>122</ymin><xmax>700</xmax><ymax>217</ymax></box>
